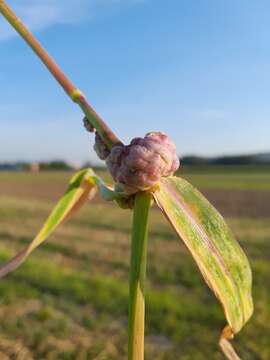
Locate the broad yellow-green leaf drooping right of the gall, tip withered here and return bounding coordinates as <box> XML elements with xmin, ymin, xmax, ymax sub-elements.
<box><xmin>153</xmin><ymin>177</ymin><xmax>253</xmax><ymax>358</ymax></box>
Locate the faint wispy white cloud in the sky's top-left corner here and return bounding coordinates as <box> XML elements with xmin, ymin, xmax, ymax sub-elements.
<box><xmin>0</xmin><ymin>0</ymin><xmax>143</xmax><ymax>40</ymax></box>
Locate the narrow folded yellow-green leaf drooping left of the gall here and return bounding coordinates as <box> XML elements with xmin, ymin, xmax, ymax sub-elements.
<box><xmin>0</xmin><ymin>169</ymin><xmax>97</xmax><ymax>278</ymax></box>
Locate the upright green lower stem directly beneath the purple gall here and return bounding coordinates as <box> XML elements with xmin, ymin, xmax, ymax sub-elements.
<box><xmin>128</xmin><ymin>192</ymin><xmax>152</xmax><ymax>360</ymax></box>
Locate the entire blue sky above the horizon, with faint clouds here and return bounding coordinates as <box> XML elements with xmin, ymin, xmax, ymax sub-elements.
<box><xmin>0</xmin><ymin>0</ymin><xmax>270</xmax><ymax>162</ymax></box>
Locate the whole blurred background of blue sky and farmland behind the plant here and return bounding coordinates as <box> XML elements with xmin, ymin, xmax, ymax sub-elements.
<box><xmin>0</xmin><ymin>0</ymin><xmax>270</xmax><ymax>360</ymax></box>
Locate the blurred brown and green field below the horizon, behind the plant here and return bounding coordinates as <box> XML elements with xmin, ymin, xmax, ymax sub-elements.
<box><xmin>0</xmin><ymin>168</ymin><xmax>270</xmax><ymax>360</ymax></box>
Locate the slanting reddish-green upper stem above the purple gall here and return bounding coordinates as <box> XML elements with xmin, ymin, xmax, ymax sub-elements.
<box><xmin>0</xmin><ymin>0</ymin><xmax>121</xmax><ymax>149</ymax></box>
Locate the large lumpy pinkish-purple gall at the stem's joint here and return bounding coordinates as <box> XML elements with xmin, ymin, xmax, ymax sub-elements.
<box><xmin>106</xmin><ymin>132</ymin><xmax>180</xmax><ymax>194</ymax></box>
